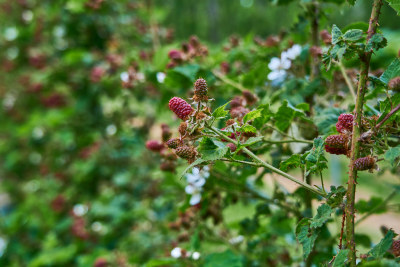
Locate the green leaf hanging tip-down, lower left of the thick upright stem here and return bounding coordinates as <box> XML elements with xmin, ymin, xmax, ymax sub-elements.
<box><xmin>296</xmin><ymin>218</ymin><xmax>319</xmax><ymax>259</ymax></box>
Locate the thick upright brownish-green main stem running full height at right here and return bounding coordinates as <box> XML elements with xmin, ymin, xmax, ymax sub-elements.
<box><xmin>345</xmin><ymin>0</ymin><xmax>383</xmax><ymax>267</ymax></box>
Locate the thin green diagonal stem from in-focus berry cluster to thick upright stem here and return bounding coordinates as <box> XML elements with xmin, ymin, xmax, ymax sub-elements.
<box><xmin>206</xmin><ymin>126</ymin><xmax>326</xmax><ymax>198</ymax></box>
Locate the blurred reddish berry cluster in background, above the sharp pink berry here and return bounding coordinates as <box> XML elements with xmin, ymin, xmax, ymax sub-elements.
<box><xmin>167</xmin><ymin>36</ymin><xmax>208</xmax><ymax>68</ymax></box>
